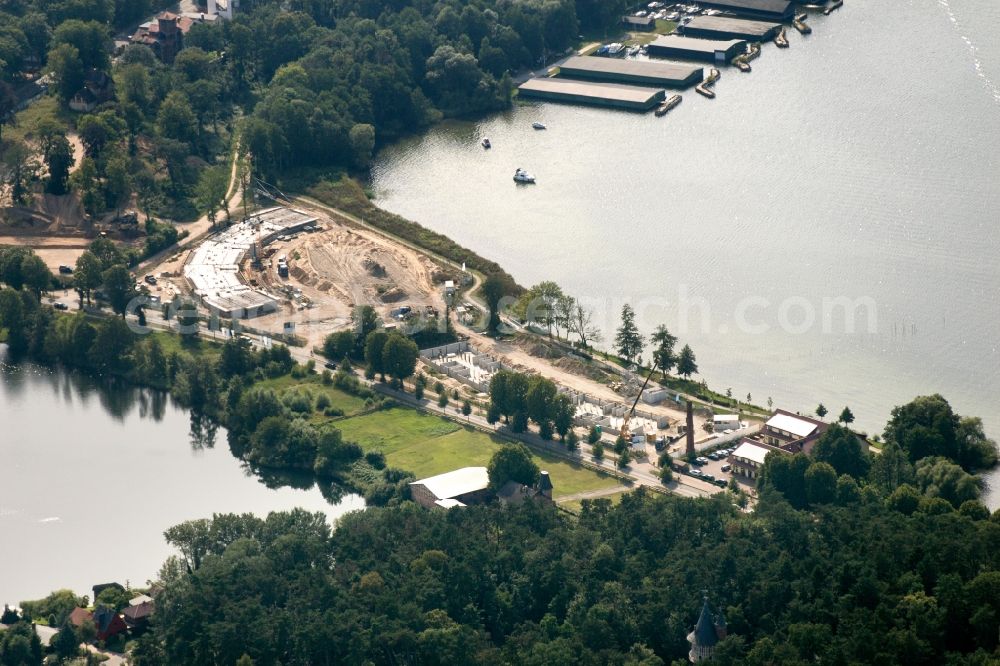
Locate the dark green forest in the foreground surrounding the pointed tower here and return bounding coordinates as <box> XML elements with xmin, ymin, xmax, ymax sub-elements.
<box><xmin>107</xmin><ymin>470</ymin><xmax>1000</xmax><ymax>665</ymax></box>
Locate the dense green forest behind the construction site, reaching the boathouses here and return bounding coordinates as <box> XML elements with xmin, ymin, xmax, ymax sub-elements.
<box><xmin>0</xmin><ymin>0</ymin><xmax>623</xmax><ymax>219</ymax></box>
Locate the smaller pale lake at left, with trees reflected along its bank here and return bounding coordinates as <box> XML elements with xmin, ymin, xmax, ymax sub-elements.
<box><xmin>0</xmin><ymin>346</ymin><xmax>364</xmax><ymax>604</ymax></box>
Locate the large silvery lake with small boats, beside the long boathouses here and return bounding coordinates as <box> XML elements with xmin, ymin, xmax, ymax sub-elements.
<box><xmin>372</xmin><ymin>0</ymin><xmax>1000</xmax><ymax>506</ymax></box>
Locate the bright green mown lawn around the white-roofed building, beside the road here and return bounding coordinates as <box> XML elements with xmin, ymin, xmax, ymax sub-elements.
<box><xmin>337</xmin><ymin>408</ymin><xmax>619</xmax><ymax>497</ymax></box>
